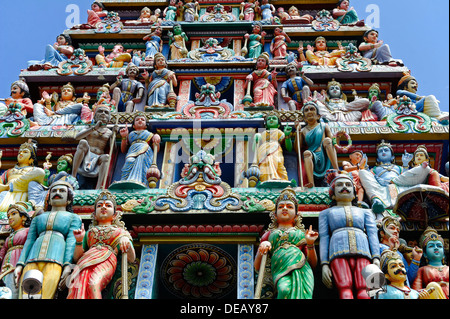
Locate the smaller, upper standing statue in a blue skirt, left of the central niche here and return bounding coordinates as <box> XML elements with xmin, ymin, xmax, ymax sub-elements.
<box><xmin>142</xmin><ymin>53</ymin><xmax>178</xmax><ymax>107</ymax></box>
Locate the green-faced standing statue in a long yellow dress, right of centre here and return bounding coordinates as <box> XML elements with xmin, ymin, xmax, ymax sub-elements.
<box><xmin>255</xmin><ymin>114</ymin><xmax>292</xmax><ymax>182</ymax></box>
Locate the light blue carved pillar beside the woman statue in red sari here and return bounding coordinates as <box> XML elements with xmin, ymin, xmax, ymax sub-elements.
<box><xmin>134</xmin><ymin>244</ymin><xmax>158</xmax><ymax>299</ymax></box>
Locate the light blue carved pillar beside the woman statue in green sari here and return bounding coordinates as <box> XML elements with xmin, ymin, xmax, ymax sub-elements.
<box><xmin>237</xmin><ymin>244</ymin><xmax>255</xmax><ymax>299</ymax></box>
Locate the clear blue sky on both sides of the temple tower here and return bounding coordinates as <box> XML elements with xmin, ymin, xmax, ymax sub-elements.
<box><xmin>0</xmin><ymin>0</ymin><xmax>449</xmax><ymax>111</ymax></box>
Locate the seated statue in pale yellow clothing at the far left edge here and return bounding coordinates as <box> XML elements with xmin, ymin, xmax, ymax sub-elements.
<box><xmin>0</xmin><ymin>140</ymin><xmax>45</xmax><ymax>212</ymax></box>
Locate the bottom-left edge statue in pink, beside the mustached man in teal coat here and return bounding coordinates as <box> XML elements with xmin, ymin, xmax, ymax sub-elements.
<box><xmin>0</xmin><ymin>202</ymin><xmax>33</xmax><ymax>299</ymax></box>
